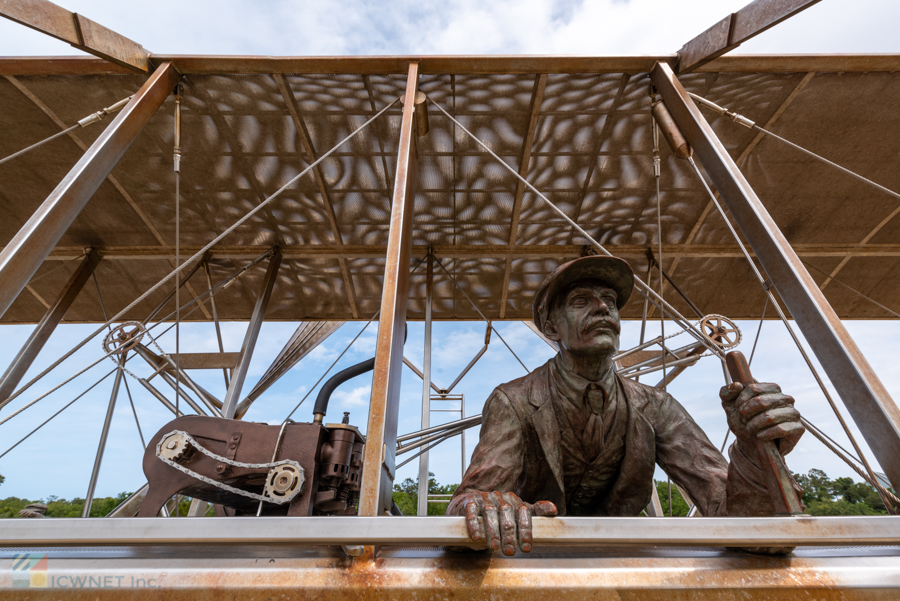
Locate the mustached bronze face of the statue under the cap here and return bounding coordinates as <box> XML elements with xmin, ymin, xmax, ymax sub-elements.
<box><xmin>544</xmin><ymin>281</ymin><xmax>620</xmax><ymax>356</ymax></box>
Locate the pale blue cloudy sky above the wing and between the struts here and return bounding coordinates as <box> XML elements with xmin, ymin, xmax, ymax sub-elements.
<box><xmin>0</xmin><ymin>0</ymin><xmax>900</xmax><ymax>499</ymax></box>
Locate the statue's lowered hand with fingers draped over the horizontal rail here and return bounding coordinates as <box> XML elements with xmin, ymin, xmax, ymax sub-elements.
<box><xmin>460</xmin><ymin>491</ymin><xmax>556</xmax><ymax>555</ymax></box>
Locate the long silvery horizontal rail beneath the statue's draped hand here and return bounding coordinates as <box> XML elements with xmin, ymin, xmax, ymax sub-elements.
<box><xmin>7</xmin><ymin>516</ymin><xmax>900</xmax><ymax>547</ymax></box>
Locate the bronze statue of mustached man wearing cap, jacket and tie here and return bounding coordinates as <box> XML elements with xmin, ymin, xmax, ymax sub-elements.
<box><xmin>447</xmin><ymin>256</ymin><xmax>804</xmax><ymax>555</ymax></box>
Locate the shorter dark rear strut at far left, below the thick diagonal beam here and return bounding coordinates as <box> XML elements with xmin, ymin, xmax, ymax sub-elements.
<box><xmin>0</xmin><ymin>246</ymin><xmax>101</xmax><ymax>408</ymax></box>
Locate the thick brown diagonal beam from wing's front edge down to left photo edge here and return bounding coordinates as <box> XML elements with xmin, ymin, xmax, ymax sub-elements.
<box><xmin>0</xmin><ymin>64</ymin><xmax>177</xmax><ymax>315</ymax></box>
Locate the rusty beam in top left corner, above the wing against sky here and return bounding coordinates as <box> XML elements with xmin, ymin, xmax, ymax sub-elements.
<box><xmin>0</xmin><ymin>0</ymin><xmax>150</xmax><ymax>73</ymax></box>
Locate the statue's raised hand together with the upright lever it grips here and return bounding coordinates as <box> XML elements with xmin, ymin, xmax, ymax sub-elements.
<box><xmin>720</xmin><ymin>351</ymin><xmax>805</xmax><ymax>515</ymax></box>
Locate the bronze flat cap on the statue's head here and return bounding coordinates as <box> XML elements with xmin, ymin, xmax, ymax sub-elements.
<box><xmin>532</xmin><ymin>256</ymin><xmax>634</xmax><ymax>331</ymax></box>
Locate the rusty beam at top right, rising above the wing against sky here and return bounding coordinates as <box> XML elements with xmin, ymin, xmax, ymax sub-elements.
<box><xmin>676</xmin><ymin>0</ymin><xmax>820</xmax><ymax>74</ymax></box>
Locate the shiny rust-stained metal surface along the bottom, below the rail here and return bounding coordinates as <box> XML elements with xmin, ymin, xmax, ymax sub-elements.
<box><xmin>0</xmin><ymin>547</ymin><xmax>900</xmax><ymax>601</ymax></box>
